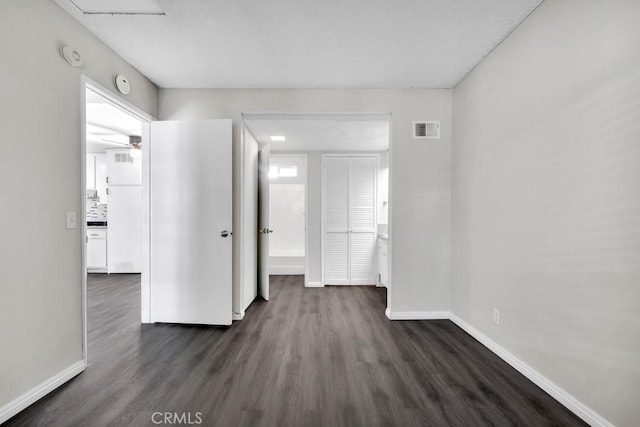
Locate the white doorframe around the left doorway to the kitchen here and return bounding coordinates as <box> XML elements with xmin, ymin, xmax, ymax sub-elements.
<box><xmin>79</xmin><ymin>74</ymin><xmax>156</xmax><ymax>364</ymax></box>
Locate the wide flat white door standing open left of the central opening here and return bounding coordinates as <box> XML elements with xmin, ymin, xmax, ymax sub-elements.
<box><xmin>149</xmin><ymin>119</ymin><xmax>232</xmax><ymax>325</ymax></box>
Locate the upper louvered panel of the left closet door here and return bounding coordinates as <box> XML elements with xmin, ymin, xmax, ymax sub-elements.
<box><xmin>324</xmin><ymin>158</ymin><xmax>349</xmax><ymax>231</ymax></box>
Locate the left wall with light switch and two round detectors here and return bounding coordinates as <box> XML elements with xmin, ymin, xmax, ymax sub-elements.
<box><xmin>0</xmin><ymin>0</ymin><xmax>158</xmax><ymax>418</ymax></box>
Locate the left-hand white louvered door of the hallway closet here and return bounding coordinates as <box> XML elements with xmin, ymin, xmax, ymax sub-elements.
<box><xmin>323</xmin><ymin>157</ymin><xmax>349</xmax><ymax>285</ymax></box>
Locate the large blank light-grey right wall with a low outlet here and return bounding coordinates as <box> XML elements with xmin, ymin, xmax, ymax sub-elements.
<box><xmin>450</xmin><ymin>0</ymin><xmax>640</xmax><ymax>426</ymax></box>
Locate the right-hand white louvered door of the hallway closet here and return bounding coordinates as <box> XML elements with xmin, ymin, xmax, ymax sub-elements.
<box><xmin>349</xmin><ymin>157</ymin><xmax>376</xmax><ymax>285</ymax></box>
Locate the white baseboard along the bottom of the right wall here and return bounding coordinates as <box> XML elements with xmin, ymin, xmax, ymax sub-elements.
<box><xmin>448</xmin><ymin>313</ymin><xmax>613</xmax><ymax>427</ymax></box>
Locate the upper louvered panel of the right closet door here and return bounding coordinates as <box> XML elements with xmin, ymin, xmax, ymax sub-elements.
<box><xmin>349</xmin><ymin>157</ymin><xmax>376</xmax><ymax>231</ymax></box>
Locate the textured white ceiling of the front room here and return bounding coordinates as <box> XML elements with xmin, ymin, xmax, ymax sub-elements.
<box><xmin>54</xmin><ymin>0</ymin><xmax>541</xmax><ymax>88</ymax></box>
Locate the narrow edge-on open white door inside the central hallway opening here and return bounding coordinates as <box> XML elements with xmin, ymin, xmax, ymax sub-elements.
<box><xmin>258</xmin><ymin>145</ymin><xmax>273</xmax><ymax>301</ymax></box>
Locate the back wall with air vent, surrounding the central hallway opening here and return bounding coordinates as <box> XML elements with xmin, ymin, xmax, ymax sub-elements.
<box><xmin>160</xmin><ymin>89</ymin><xmax>452</xmax><ymax>312</ymax></box>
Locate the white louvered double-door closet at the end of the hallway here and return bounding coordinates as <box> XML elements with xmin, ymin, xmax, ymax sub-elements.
<box><xmin>322</xmin><ymin>155</ymin><xmax>378</xmax><ymax>285</ymax></box>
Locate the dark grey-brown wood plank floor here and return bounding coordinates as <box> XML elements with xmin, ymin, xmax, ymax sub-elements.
<box><xmin>8</xmin><ymin>275</ymin><xmax>584</xmax><ymax>426</ymax></box>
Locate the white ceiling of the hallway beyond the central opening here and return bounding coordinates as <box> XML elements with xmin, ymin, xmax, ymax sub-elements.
<box><xmin>243</xmin><ymin>114</ymin><xmax>389</xmax><ymax>153</ymax></box>
